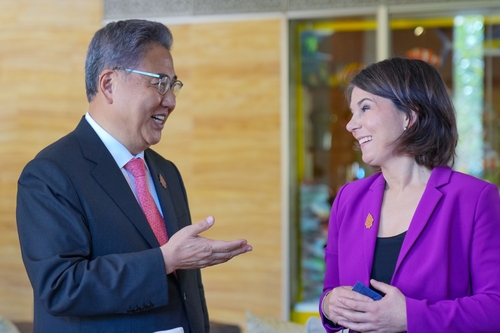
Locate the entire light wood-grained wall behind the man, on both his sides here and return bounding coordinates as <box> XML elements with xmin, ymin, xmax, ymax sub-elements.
<box><xmin>0</xmin><ymin>0</ymin><xmax>283</xmax><ymax>326</ymax></box>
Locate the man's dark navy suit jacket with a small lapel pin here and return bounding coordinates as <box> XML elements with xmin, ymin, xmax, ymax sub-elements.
<box><xmin>17</xmin><ymin>119</ymin><xmax>209</xmax><ymax>333</ymax></box>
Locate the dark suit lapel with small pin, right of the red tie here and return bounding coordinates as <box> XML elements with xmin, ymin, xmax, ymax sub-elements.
<box><xmin>144</xmin><ymin>150</ymin><xmax>179</xmax><ymax>237</ymax></box>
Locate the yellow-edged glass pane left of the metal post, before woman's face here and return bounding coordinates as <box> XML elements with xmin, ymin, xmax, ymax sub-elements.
<box><xmin>290</xmin><ymin>16</ymin><xmax>376</xmax><ymax>322</ymax></box>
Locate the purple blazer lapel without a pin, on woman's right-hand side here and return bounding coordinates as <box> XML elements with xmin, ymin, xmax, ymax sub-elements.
<box><xmin>392</xmin><ymin>167</ymin><xmax>452</xmax><ymax>280</ymax></box>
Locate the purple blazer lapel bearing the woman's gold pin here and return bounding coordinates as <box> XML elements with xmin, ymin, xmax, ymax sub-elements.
<box><xmin>364</xmin><ymin>174</ymin><xmax>385</xmax><ymax>283</ymax></box>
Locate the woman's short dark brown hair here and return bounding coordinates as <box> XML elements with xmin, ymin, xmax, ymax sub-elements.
<box><xmin>346</xmin><ymin>58</ymin><xmax>458</xmax><ymax>169</ymax></box>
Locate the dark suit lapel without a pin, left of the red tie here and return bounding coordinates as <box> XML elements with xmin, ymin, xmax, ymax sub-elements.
<box><xmin>75</xmin><ymin>119</ymin><xmax>159</xmax><ymax>247</ymax></box>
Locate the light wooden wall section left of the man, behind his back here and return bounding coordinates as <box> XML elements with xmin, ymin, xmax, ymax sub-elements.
<box><xmin>0</xmin><ymin>0</ymin><xmax>102</xmax><ymax>321</ymax></box>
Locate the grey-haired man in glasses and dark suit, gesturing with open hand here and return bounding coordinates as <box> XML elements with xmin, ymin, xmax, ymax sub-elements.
<box><xmin>17</xmin><ymin>20</ymin><xmax>252</xmax><ymax>333</ymax></box>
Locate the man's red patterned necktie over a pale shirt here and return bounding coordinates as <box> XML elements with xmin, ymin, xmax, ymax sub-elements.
<box><xmin>124</xmin><ymin>158</ymin><xmax>168</xmax><ymax>245</ymax></box>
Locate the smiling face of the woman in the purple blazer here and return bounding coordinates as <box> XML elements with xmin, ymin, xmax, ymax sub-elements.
<box><xmin>346</xmin><ymin>87</ymin><xmax>408</xmax><ymax>167</ymax></box>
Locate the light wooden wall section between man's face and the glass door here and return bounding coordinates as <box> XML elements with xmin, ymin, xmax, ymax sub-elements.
<box><xmin>164</xmin><ymin>19</ymin><xmax>283</xmax><ymax>327</ymax></box>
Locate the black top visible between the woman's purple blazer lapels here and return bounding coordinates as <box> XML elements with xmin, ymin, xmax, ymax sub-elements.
<box><xmin>370</xmin><ymin>231</ymin><xmax>406</xmax><ymax>294</ymax></box>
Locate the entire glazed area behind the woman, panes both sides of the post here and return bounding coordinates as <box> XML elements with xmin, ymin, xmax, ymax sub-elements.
<box><xmin>289</xmin><ymin>3</ymin><xmax>500</xmax><ymax>322</ymax></box>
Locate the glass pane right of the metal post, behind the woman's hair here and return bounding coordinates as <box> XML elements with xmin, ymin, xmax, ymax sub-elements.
<box><xmin>391</xmin><ymin>14</ymin><xmax>500</xmax><ymax>185</ymax></box>
